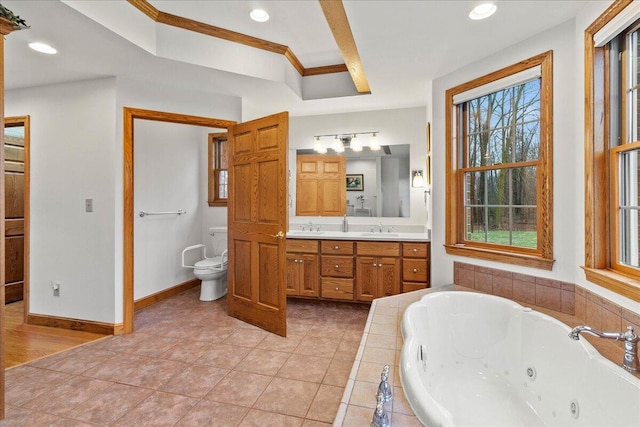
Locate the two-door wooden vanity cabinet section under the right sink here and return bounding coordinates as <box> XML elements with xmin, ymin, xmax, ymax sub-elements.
<box><xmin>355</xmin><ymin>242</ymin><xmax>400</xmax><ymax>302</ymax></box>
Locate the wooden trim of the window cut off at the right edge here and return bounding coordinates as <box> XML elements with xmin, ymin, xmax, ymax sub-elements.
<box><xmin>582</xmin><ymin>0</ymin><xmax>640</xmax><ymax>301</ymax></box>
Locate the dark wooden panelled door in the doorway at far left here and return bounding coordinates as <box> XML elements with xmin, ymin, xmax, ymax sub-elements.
<box><xmin>4</xmin><ymin>118</ymin><xmax>27</xmax><ymax>304</ymax></box>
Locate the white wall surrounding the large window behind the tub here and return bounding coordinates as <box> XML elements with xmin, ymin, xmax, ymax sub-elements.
<box><xmin>431</xmin><ymin>13</ymin><xmax>638</xmax><ymax>311</ymax></box>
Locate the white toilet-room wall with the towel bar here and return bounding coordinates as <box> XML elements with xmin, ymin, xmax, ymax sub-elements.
<box><xmin>134</xmin><ymin>120</ymin><xmax>206</xmax><ymax>300</ymax></box>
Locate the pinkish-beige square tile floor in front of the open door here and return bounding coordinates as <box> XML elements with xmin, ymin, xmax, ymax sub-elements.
<box><xmin>0</xmin><ymin>288</ymin><xmax>368</xmax><ymax>427</ymax></box>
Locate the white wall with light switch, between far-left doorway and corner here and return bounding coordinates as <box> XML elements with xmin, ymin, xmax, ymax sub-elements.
<box><xmin>5</xmin><ymin>79</ymin><xmax>117</xmax><ymax>322</ymax></box>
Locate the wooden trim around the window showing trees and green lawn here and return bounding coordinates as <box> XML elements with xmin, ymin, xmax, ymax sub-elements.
<box><xmin>445</xmin><ymin>51</ymin><xmax>554</xmax><ymax>270</ymax></box>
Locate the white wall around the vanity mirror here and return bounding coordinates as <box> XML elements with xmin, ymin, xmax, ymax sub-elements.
<box><xmin>289</xmin><ymin>107</ymin><xmax>427</xmax><ymax>225</ymax></box>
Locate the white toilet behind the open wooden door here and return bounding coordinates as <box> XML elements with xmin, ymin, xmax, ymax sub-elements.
<box><xmin>182</xmin><ymin>227</ymin><xmax>228</xmax><ymax>301</ymax></box>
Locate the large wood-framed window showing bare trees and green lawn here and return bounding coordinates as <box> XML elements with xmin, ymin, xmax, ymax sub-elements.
<box><xmin>445</xmin><ymin>52</ymin><xmax>553</xmax><ymax>270</ymax></box>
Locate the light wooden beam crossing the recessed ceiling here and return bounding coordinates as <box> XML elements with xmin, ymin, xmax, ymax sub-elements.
<box><xmin>318</xmin><ymin>0</ymin><xmax>371</xmax><ymax>93</ymax></box>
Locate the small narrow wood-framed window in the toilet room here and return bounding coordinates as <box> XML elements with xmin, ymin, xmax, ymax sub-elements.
<box><xmin>209</xmin><ymin>133</ymin><xmax>229</xmax><ymax>206</ymax></box>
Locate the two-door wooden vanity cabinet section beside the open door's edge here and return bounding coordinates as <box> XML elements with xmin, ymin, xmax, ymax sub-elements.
<box><xmin>287</xmin><ymin>239</ymin><xmax>320</xmax><ymax>298</ymax></box>
